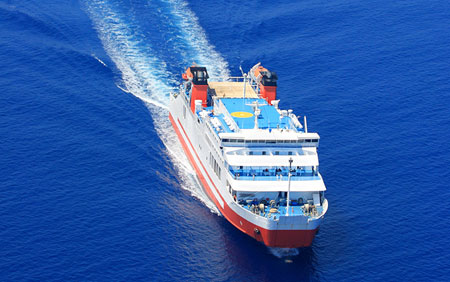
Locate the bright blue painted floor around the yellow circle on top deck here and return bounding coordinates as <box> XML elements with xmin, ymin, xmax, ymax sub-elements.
<box><xmin>220</xmin><ymin>98</ymin><xmax>292</xmax><ymax>129</ymax></box>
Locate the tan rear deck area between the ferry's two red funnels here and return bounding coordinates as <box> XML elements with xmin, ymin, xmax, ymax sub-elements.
<box><xmin>208</xmin><ymin>81</ymin><xmax>258</xmax><ymax>98</ymax></box>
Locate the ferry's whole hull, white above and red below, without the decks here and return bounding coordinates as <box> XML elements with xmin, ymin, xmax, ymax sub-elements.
<box><xmin>169</xmin><ymin>86</ymin><xmax>328</xmax><ymax>248</ymax></box>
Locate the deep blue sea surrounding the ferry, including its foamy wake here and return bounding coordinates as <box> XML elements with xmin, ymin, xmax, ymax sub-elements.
<box><xmin>0</xmin><ymin>0</ymin><xmax>450</xmax><ymax>281</ymax></box>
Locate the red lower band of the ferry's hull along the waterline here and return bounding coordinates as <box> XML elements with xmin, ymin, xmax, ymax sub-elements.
<box><xmin>169</xmin><ymin>114</ymin><xmax>318</xmax><ymax>248</ymax></box>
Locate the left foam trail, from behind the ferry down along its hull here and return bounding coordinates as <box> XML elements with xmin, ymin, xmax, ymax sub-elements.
<box><xmin>85</xmin><ymin>1</ymin><xmax>223</xmax><ymax>214</ymax></box>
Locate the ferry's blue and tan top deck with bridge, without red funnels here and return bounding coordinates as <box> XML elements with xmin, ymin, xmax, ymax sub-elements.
<box><xmin>196</xmin><ymin>81</ymin><xmax>319</xmax><ymax>145</ymax></box>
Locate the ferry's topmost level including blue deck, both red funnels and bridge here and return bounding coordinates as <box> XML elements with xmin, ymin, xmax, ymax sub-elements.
<box><xmin>181</xmin><ymin>64</ymin><xmax>319</xmax><ymax>147</ymax></box>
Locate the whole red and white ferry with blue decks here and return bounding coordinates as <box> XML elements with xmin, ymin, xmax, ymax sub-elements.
<box><xmin>169</xmin><ymin>63</ymin><xmax>328</xmax><ymax>248</ymax></box>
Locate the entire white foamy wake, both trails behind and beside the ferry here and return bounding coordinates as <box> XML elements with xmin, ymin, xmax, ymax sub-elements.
<box><xmin>85</xmin><ymin>0</ymin><xmax>225</xmax><ymax>214</ymax></box>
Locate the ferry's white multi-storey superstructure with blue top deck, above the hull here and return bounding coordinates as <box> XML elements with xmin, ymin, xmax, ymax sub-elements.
<box><xmin>175</xmin><ymin>65</ymin><xmax>325</xmax><ymax>189</ymax></box>
